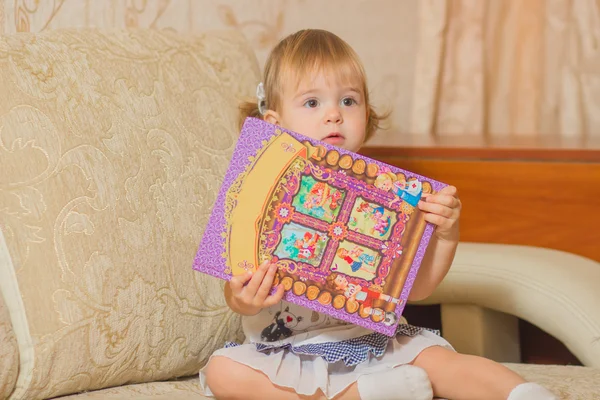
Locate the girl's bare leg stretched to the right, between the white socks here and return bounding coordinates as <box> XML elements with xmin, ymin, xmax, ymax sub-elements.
<box><xmin>413</xmin><ymin>346</ymin><xmax>549</xmax><ymax>400</ymax></box>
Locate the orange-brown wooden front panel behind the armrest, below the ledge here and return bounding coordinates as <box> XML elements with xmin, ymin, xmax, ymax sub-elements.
<box><xmin>366</xmin><ymin>157</ymin><xmax>600</xmax><ymax>261</ymax></box>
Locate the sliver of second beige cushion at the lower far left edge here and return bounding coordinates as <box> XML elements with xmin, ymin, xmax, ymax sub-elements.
<box><xmin>0</xmin><ymin>282</ymin><xmax>19</xmax><ymax>399</ymax></box>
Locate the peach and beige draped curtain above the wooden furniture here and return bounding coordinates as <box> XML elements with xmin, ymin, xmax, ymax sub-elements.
<box><xmin>410</xmin><ymin>0</ymin><xmax>600</xmax><ymax>139</ymax></box>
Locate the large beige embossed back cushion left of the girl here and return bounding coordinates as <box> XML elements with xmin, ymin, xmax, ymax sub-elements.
<box><xmin>0</xmin><ymin>30</ymin><xmax>259</xmax><ymax>399</ymax></box>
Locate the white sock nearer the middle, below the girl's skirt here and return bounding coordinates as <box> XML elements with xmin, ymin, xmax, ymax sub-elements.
<box><xmin>357</xmin><ymin>365</ymin><xmax>433</xmax><ymax>400</ymax></box>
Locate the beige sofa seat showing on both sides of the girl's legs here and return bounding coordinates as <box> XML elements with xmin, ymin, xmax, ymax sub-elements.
<box><xmin>52</xmin><ymin>364</ymin><xmax>600</xmax><ymax>400</ymax></box>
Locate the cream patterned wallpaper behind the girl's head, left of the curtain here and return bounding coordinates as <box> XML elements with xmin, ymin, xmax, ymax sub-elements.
<box><xmin>0</xmin><ymin>0</ymin><xmax>418</xmax><ymax>134</ymax></box>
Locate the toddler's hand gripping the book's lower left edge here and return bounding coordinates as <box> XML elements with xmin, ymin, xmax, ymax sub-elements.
<box><xmin>225</xmin><ymin>261</ymin><xmax>284</xmax><ymax>316</ymax></box>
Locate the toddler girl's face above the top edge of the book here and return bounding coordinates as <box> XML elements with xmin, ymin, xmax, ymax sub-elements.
<box><xmin>265</xmin><ymin>70</ymin><xmax>367</xmax><ymax>152</ymax></box>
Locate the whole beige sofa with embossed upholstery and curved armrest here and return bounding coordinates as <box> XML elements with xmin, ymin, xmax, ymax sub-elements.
<box><xmin>0</xmin><ymin>31</ymin><xmax>600</xmax><ymax>400</ymax></box>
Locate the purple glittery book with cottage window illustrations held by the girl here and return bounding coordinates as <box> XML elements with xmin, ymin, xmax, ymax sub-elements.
<box><xmin>193</xmin><ymin>118</ymin><xmax>446</xmax><ymax>336</ymax></box>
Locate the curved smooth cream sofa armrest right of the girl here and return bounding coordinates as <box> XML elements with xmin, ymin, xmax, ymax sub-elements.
<box><xmin>419</xmin><ymin>243</ymin><xmax>600</xmax><ymax>367</ymax></box>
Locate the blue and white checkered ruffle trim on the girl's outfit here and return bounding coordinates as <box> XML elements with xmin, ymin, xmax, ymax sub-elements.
<box><xmin>225</xmin><ymin>324</ymin><xmax>440</xmax><ymax>367</ymax></box>
